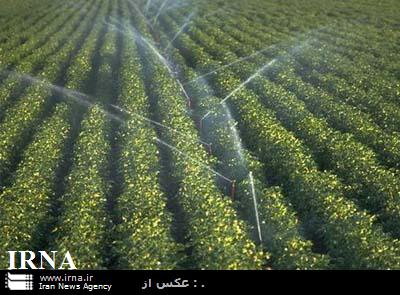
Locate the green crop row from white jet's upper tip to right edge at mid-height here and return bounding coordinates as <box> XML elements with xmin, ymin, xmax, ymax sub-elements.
<box><xmin>193</xmin><ymin>13</ymin><xmax>400</xmax><ymax>171</ymax></box>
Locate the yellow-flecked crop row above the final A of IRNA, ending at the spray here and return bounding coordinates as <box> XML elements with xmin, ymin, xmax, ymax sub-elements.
<box><xmin>53</xmin><ymin>105</ymin><xmax>110</xmax><ymax>269</ymax></box>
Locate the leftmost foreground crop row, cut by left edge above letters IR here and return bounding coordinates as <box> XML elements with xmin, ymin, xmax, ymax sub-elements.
<box><xmin>0</xmin><ymin>104</ymin><xmax>70</xmax><ymax>269</ymax></box>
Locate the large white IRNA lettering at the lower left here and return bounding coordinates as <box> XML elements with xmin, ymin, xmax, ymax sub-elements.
<box><xmin>7</xmin><ymin>251</ymin><xmax>76</xmax><ymax>270</ymax></box>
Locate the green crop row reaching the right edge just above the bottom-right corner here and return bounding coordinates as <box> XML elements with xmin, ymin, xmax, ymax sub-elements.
<box><xmin>176</xmin><ymin>13</ymin><xmax>400</xmax><ymax>236</ymax></box>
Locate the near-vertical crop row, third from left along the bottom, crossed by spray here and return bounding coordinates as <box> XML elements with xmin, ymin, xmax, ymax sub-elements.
<box><xmin>115</xmin><ymin>2</ymin><xmax>180</xmax><ymax>269</ymax></box>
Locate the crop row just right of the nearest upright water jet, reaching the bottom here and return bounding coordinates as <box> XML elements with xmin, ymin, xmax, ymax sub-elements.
<box><xmin>191</xmin><ymin>73</ymin><xmax>329</xmax><ymax>269</ymax></box>
